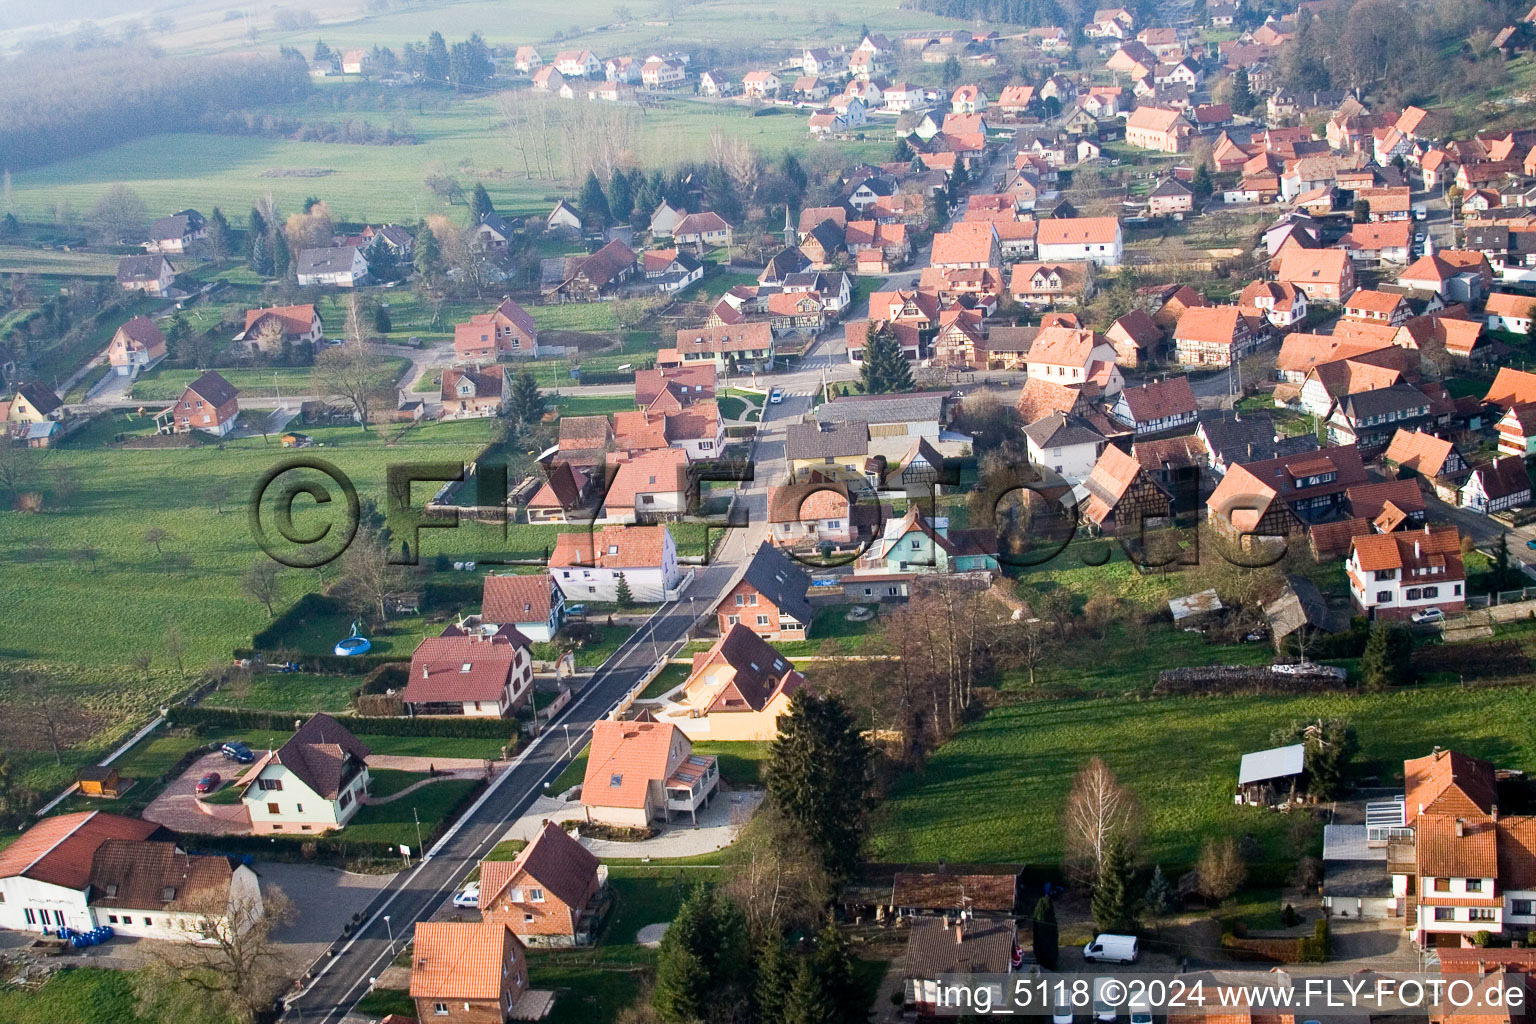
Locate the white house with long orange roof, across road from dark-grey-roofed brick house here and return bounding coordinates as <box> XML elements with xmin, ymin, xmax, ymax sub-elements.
<box><xmin>550</xmin><ymin>525</ymin><xmax>682</xmax><ymax>603</ymax></box>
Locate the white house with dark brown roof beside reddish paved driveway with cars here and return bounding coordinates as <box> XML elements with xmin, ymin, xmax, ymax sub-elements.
<box><xmin>240</xmin><ymin>714</ymin><xmax>370</xmax><ymax>835</ymax></box>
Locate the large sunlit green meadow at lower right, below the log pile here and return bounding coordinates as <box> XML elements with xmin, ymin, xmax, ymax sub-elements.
<box><xmin>871</xmin><ymin>686</ymin><xmax>1536</xmax><ymax>875</ymax></box>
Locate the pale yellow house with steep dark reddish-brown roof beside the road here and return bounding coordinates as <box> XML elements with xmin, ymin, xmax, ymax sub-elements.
<box><xmin>662</xmin><ymin>625</ymin><xmax>805</xmax><ymax>740</ymax></box>
